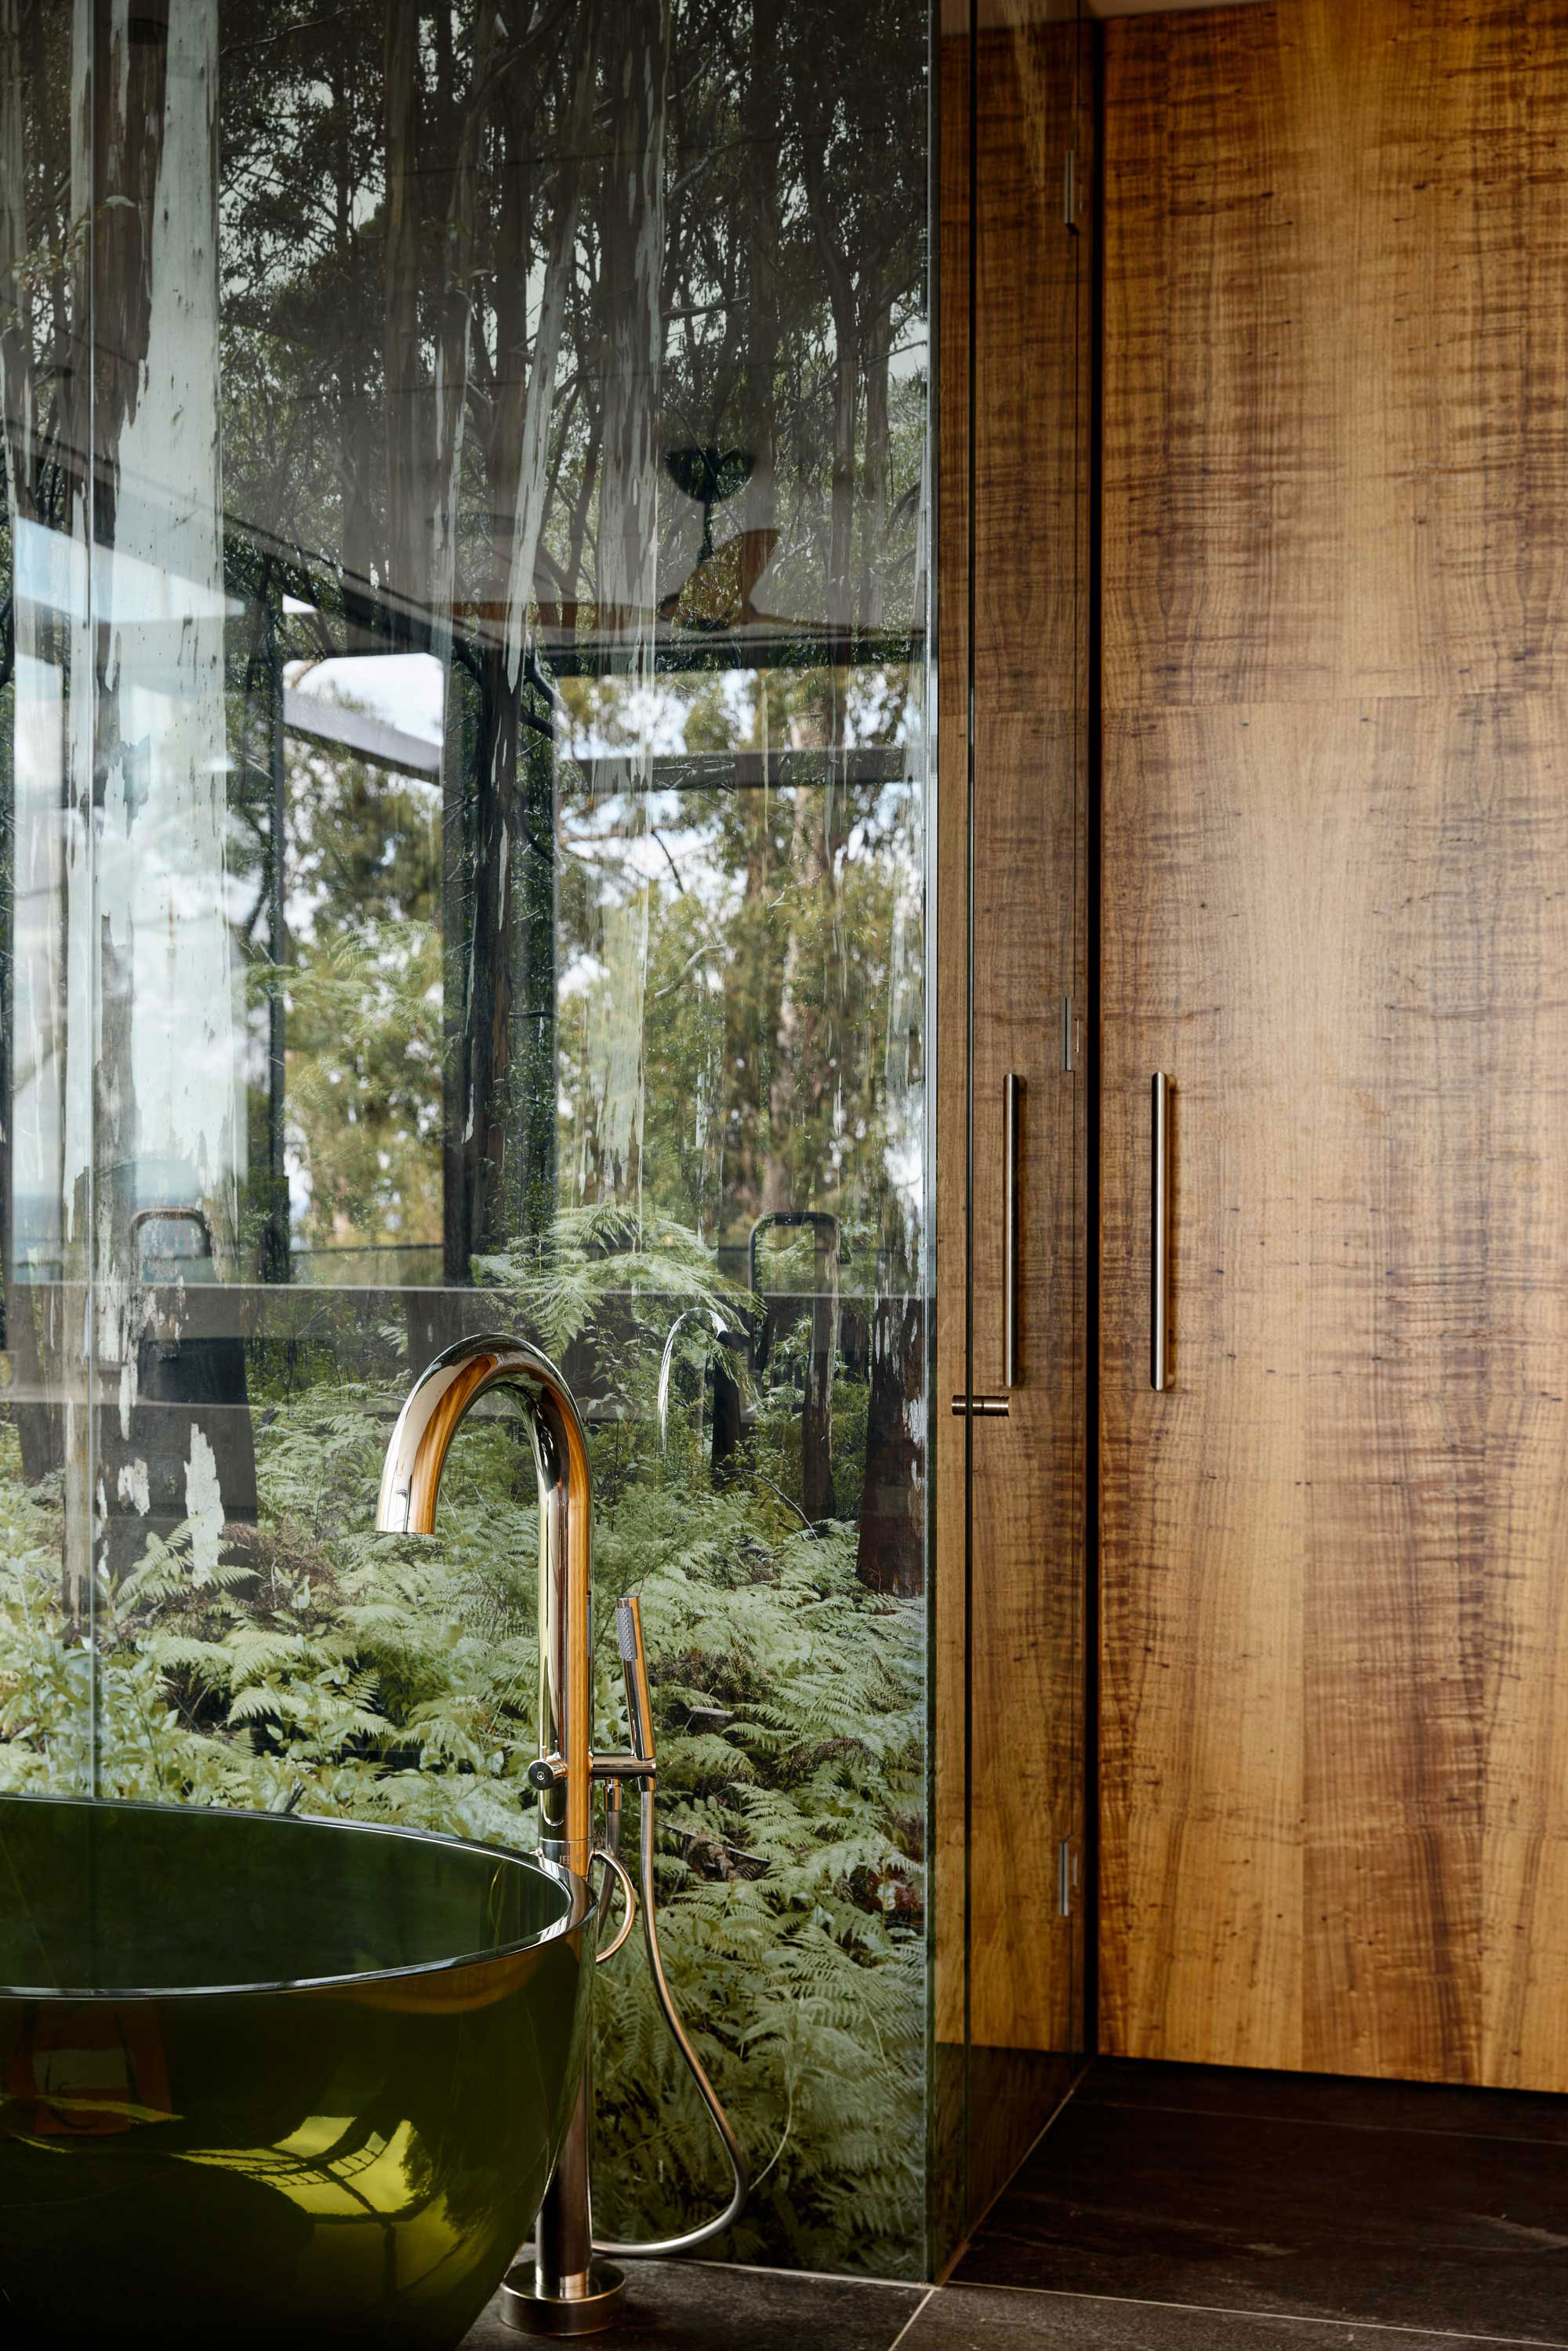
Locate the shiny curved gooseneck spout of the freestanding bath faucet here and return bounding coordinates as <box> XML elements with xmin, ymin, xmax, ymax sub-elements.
<box><xmin>376</xmin><ymin>1331</ymin><xmax>593</xmax><ymax>1876</ymax></box>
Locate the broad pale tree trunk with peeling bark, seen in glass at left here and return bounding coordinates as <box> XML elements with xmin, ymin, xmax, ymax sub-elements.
<box><xmin>87</xmin><ymin>0</ymin><xmax>256</xmax><ymax>1575</ymax></box>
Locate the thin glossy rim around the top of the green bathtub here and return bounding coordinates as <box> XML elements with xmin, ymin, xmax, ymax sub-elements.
<box><xmin>0</xmin><ymin>1789</ymin><xmax>595</xmax><ymax>2008</ymax></box>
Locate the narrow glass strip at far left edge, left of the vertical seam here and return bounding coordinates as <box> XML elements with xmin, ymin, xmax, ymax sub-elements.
<box><xmin>0</xmin><ymin>7</ymin><xmax>94</xmax><ymax>1791</ymax></box>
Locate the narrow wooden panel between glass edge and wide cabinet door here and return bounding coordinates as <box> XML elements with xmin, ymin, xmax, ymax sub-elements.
<box><xmin>971</xmin><ymin>7</ymin><xmax>1086</xmax><ymax>2052</ymax></box>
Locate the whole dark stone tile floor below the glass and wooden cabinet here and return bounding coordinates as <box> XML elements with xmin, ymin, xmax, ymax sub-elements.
<box><xmin>466</xmin><ymin>2062</ymin><xmax>1568</xmax><ymax>2351</ymax></box>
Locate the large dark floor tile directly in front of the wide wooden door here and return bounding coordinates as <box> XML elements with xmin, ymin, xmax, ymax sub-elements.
<box><xmin>956</xmin><ymin>2062</ymin><xmax>1568</xmax><ymax>2344</ymax></box>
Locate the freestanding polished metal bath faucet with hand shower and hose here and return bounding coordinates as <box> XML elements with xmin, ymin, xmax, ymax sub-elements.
<box><xmin>376</xmin><ymin>1333</ymin><xmax>748</xmax><ymax>2335</ymax></box>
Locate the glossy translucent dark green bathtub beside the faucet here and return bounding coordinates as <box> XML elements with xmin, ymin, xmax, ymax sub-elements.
<box><xmin>0</xmin><ymin>1796</ymin><xmax>593</xmax><ymax>2351</ymax></box>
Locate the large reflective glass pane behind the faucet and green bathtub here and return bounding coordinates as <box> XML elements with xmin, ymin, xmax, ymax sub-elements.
<box><xmin>5</xmin><ymin>0</ymin><xmax>931</xmax><ymax>2273</ymax></box>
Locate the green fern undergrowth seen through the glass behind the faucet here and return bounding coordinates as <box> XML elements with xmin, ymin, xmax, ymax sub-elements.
<box><xmin>0</xmin><ymin>1211</ymin><xmax>924</xmax><ymax>2273</ymax></box>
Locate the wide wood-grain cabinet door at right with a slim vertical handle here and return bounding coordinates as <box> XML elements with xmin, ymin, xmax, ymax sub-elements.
<box><xmin>1100</xmin><ymin>0</ymin><xmax>1568</xmax><ymax>2090</ymax></box>
